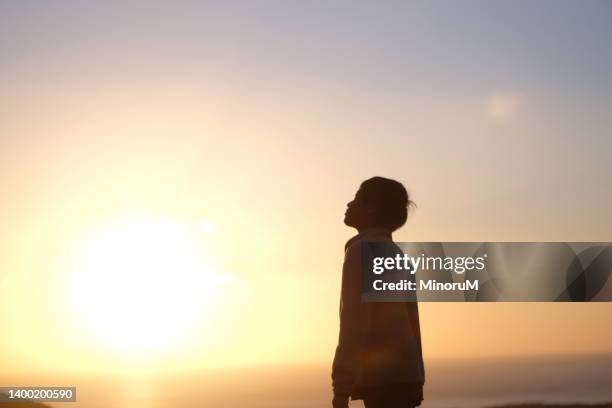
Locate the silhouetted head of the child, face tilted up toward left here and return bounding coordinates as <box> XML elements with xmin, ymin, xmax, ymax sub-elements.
<box><xmin>344</xmin><ymin>177</ymin><xmax>412</xmax><ymax>231</ymax></box>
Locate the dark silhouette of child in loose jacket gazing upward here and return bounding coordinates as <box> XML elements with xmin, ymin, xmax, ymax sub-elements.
<box><xmin>332</xmin><ymin>177</ymin><xmax>425</xmax><ymax>408</ymax></box>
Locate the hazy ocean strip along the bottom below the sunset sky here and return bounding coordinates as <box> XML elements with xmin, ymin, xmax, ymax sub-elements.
<box><xmin>0</xmin><ymin>355</ymin><xmax>612</xmax><ymax>408</ymax></box>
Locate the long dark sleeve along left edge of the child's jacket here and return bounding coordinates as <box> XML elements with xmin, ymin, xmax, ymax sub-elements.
<box><xmin>332</xmin><ymin>243</ymin><xmax>371</xmax><ymax>395</ymax></box>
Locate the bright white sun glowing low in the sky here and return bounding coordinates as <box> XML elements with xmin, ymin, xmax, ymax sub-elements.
<box><xmin>71</xmin><ymin>218</ymin><xmax>216</xmax><ymax>355</ymax></box>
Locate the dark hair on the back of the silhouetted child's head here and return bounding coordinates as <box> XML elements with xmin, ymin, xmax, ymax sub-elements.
<box><xmin>361</xmin><ymin>177</ymin><xmax>414</xmax><ymax>231</ymax></box>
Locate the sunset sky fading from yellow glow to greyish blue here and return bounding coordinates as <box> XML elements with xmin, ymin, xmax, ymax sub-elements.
<box><xmin>0</xmin><ymin>1</ymin><xmax>612</xmax><ymax>371</ymax></box>
